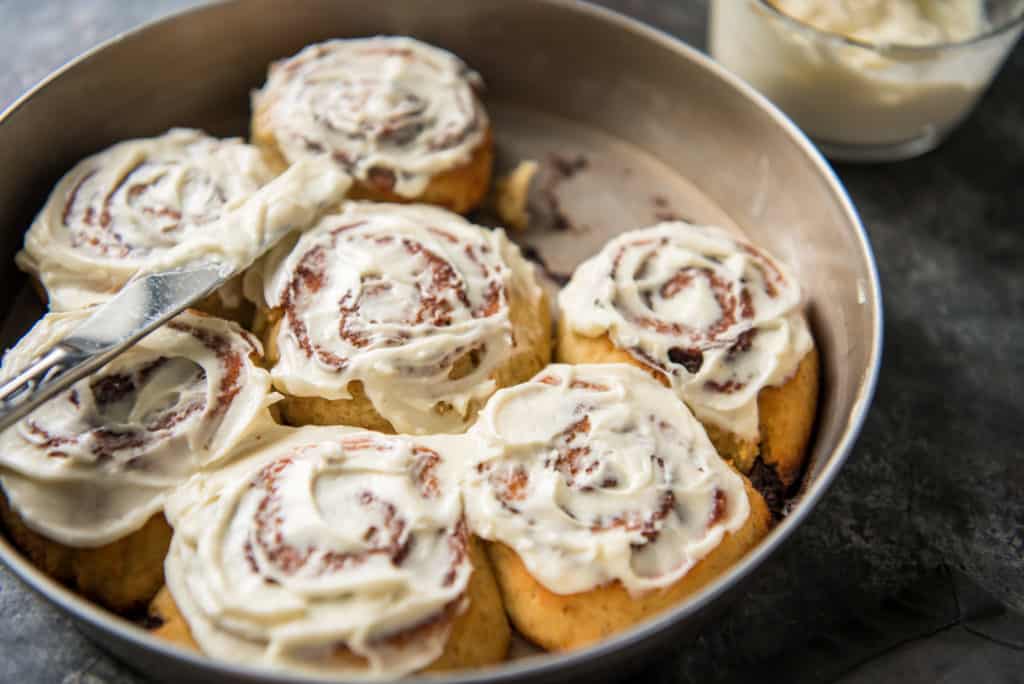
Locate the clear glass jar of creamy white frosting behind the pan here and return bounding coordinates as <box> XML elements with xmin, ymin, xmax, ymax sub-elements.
<box><xmin>709</xmin><ymin>0</ymin><xmax>1024</xmax><ymax>162</ymax></box>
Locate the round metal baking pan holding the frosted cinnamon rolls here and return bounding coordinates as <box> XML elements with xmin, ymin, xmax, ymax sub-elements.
<box><xmin>0</xmin><ymin>0</ymin><xmax>882</xmax><ymax>684</ymax></box>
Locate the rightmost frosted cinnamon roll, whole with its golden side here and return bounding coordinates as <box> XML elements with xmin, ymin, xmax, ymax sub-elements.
<box><xmin>558</xmin><ymin>221</ymin><xmax>818</xmax><ymax>486</ymax></box>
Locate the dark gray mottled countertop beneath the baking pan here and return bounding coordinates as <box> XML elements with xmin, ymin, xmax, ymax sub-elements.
<box><xmin>0</xmin><ymin>0</ymin><xmax>1024</xmax><ymax>684</ymax></box>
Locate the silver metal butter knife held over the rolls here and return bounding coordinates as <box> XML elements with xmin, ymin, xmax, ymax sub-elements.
<box><xmin>0</xmin><ymin>263</ymin><xmax>233</xmax><ymax>430</ymax></box>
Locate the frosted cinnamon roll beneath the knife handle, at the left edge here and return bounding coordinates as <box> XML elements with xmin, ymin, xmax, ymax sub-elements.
<box><xmin>0</xmin><ymin>310</ymin><xmax>273</xmax><ymax>611</ymax></box>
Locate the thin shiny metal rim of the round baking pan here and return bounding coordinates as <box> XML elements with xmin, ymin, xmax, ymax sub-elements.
<box><xmin>0</xmin><ymin>0</ymin><xmax>884</xmax><ymax>684</ymax></box>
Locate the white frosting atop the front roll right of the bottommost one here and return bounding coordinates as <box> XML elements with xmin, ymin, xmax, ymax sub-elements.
<box><xmin>464</xmin><ymin>364</ymin><xmax>750</xmax><ymax>594</ymax></box>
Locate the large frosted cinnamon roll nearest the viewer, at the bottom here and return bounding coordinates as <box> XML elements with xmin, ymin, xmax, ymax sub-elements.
<box><xmin>153</xmin><ymin>427</ymin><xmax>509</xmax><ymax>678</ymax></box>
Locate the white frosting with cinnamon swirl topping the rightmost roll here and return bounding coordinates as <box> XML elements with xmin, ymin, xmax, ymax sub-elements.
<box><xmin>558</xmin><ymin>221</ymin><xmax>813</xmax><ymax>439</ymax></box>
